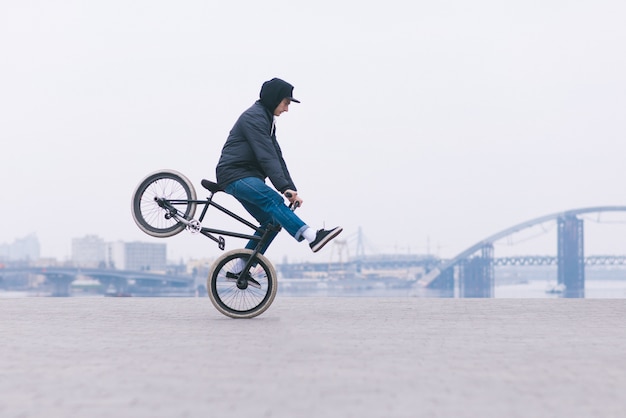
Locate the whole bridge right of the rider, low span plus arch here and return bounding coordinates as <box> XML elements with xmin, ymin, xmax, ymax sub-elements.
<box><xmin>278</xmin><ymin>206</ymin><xmax>626</xmax><ymax>297</ymax></box>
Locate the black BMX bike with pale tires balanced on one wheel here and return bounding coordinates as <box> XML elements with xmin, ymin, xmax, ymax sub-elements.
<box><xmin>132</xmin><ymin>170</ymin><xmax>296</xmax><ymax>318</ymax></box>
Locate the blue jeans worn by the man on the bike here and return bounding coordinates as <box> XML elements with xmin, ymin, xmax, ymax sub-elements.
<box><xmin>224</xmin><ymin>177</ymin><xmax>308</xmax><ymax>254</ymax></box>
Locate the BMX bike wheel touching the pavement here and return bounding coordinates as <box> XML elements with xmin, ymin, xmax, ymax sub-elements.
<box><xmin>207</xmin><ymin>249</ymin><xmax>278</xmax><ymax>318</ymax></box>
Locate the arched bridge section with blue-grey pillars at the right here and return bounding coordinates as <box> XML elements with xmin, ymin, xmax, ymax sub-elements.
<box><xmin>417</xmin><ymin>206</ymin><xmax>626</xmax><ymax>297</ymax></box>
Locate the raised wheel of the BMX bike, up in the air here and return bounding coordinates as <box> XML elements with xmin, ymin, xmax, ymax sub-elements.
<box><xmin>127</xmin><ymin>170</ymin><xmax>197</xmax><ymax>238</ymax></box>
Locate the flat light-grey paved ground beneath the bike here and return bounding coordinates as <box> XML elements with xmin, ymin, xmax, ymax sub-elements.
<box><xmin>0</xmin><ymin>295</ymin><xmax>626</xmax><ymax>418</ymax></box>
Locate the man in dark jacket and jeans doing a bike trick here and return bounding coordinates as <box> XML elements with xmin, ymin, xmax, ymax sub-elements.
<box><xmin>216</xmin><ymin>78</ymin><xmax>343</xmax><ymax>253</ymax></box>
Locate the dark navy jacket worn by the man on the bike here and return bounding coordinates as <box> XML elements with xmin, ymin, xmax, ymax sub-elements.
<box><xmin>215</xmin><ymin>100</ymin><xmax>297</xmax><ymax>193</ymax></box>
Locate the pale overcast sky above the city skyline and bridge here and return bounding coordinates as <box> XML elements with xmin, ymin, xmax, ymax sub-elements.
<box><xmin>0</xmin><ymin>0</ymin><xmax>626</xmax><ymax>262</ymax></box>
